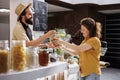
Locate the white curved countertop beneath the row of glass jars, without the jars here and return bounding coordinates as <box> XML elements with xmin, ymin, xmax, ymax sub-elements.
<box><xmin>0</xmin><ymin>61</ymin><xmax>67</xmax><ymax>80</ymax></box>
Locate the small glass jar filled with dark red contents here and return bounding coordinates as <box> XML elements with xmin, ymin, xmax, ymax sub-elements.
<box><xmin>39</xmin><ymin>50</ymin><xmax>50</xmax><ymax>66</ymax></box>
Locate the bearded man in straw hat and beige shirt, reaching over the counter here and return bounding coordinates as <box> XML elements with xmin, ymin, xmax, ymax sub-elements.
<box><xmin>12</xmin><ymin>3</ymin><xmax>55</xmax><ymax>47</ymax></box>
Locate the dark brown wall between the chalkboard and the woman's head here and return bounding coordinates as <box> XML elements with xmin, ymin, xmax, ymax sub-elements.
<box><xmin>48</xmin><ymin>8</ymin><xmax>88</xmax><ymax>45</ymax></box>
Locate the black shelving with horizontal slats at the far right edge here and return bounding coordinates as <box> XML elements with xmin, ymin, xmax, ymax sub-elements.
<box><xmin>104</xmin><ymin>14</ymin><xmax>120</xmax><ymax>67</ymax></box>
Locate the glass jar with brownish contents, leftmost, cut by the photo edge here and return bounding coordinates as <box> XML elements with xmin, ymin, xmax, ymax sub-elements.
<box><xmin>0</xmin><ymin>40</ymin><xmax>10</xmax><ymax>73</ymax></box>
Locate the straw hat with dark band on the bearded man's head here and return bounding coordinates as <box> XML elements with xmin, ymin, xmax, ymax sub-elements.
<box><xmin>15</xmin><ymin>3</ymin><xmax>32</xmax><ymax>20</ymax></box>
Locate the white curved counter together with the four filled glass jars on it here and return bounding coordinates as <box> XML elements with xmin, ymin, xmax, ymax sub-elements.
<box><xmin>0</xmin><ymin>40</ymin><xmax>67</xmax><ymax>80</ymax></box>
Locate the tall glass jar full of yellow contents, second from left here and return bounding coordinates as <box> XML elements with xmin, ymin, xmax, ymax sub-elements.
<box><xmin>12</xmin><ymin>40</ymin><xmax>26</xmax><ymax>71</ymax></box>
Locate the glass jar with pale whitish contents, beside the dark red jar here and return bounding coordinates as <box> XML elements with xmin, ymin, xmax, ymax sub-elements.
<box><xmin>26</xmin><ymin>47</ymin><xmax>39</xmax><ymax>68</ymax></box>
